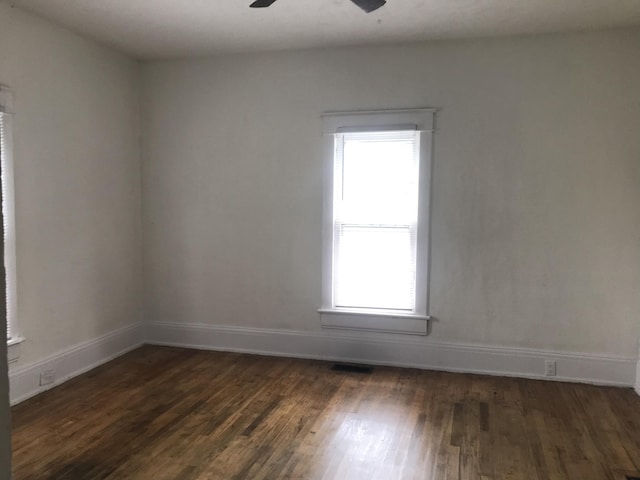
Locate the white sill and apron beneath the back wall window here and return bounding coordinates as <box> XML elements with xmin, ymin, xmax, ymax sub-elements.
<box><xmin>318</xmin><ymin>308</ymin><xmax>429</xmax><ymax>335</ymax></box>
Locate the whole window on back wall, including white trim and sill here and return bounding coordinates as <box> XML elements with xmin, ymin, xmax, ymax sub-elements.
<box><xmin>320</xmin><ymin>109</ymin><xmax>435</xmax><ymax>335</ymax></box>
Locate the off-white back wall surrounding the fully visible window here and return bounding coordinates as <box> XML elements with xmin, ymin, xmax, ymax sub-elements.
<box><xmin>142</xmin><ymin>30</ymin><xmax>640</xmax><ymax>360</ymax></box>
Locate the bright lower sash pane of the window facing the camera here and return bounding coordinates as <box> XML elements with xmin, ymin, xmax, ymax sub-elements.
<box><xmin>334</xmin><ymin>225</ymin><xmax>415</xmax><ymax>310</ymax></box>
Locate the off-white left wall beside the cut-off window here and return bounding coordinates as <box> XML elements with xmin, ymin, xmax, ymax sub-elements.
<box><xmin>0</xmin><ymin>4</ymin><xmax>142</xmax><ymax>369</ymax></box>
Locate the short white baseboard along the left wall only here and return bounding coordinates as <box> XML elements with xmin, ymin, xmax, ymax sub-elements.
<box><xmin>9</xmin><ymin>324</ymin><xmax>144</xmax><ymax>405</ymax></box>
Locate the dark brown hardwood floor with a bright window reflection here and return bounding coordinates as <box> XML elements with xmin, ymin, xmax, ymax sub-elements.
<box><xmin>8</xmin><ymin>346</ymin><xmax>640</xmax><ymax>480</ymax></box>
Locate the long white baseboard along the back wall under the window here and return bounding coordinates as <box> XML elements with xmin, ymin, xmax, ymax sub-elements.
<box><xmin>146</xmin><ymin>323</ymin><xmax>637</xmax><ymax>387</ymax></box>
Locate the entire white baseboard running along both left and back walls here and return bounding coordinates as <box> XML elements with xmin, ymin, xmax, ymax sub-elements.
<box><xmin>9</xmin><ymin>323</ymin><xmax>640</xmax><ymax>405</ymax></box>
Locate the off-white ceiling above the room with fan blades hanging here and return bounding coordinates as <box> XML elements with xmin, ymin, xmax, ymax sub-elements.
<box><xmin>9</xmin><ymin>0</ymin><xmax>640</xmax><ymax>59</ymax></box>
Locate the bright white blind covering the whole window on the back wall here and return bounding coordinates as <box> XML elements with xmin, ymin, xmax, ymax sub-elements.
<box><xmin>333</xmin><ymin>130</ymin><xmax>420</xmax><ymax>312</ymax></box>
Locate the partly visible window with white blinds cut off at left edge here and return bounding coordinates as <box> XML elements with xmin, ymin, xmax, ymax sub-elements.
<box><xmin>0</xmin><ymin>85</ymin><xmax>22</xmax><ymax>348</ymax></box>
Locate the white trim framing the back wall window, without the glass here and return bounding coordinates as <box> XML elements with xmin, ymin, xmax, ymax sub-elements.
<box><xmin>318</xmin><ymin>108</ymin><xmax>437</xmax><ymax>335</ymax></box>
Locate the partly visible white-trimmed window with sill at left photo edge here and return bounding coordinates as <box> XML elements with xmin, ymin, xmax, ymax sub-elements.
<box><xmin>0</xmin><ymin>85</ymin><xmax>24</xmax><ymax>354</ymax></box>
